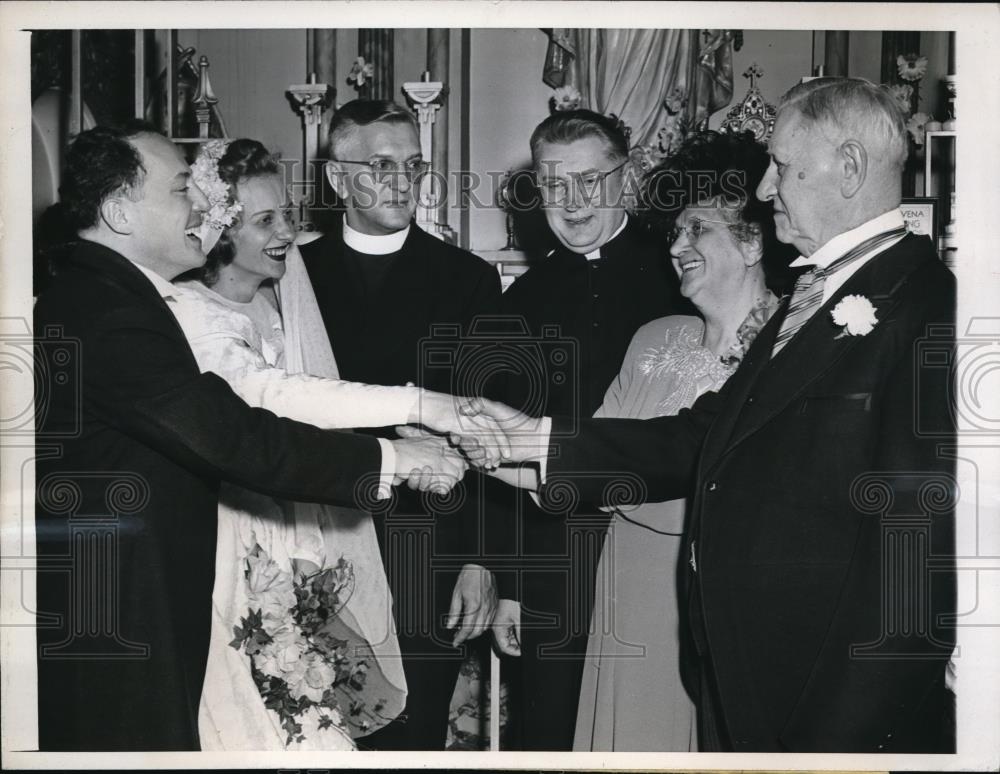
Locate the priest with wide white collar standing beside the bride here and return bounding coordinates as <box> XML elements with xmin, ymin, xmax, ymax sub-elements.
<box><xmin>301</xmin><ymin>100</ymin><xmax>500</xmax><ymax>750</ymax></box>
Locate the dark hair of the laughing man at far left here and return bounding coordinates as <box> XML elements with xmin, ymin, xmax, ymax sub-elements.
<box><xmin>59</xmin><ymin>121</ymin><xmax>160</xmax><ymax>233</ymax></box>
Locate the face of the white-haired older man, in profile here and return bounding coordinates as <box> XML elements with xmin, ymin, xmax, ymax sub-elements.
<box><xmin>757</xmin><ymin>108</ymin><xmax>843</xmax><ymax>256</ymax></box>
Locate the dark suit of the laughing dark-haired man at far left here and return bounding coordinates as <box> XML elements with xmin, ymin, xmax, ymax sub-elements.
<box><xmin>35</xmin><ymin>242</ymin><xmax>380</xmax><ymax>750</ymax></box>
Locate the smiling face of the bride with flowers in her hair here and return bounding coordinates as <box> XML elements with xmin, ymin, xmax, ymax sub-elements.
<box><xmin>220</xmin><ymin>175</ymin><xmax>295</xmax><ymax>284</ymax></box>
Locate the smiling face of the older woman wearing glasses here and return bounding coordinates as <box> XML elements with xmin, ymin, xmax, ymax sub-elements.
<box><xmin>670</xmin><ymin>203</ymin><xmax>762</xmax><ymax>312</ymax></box>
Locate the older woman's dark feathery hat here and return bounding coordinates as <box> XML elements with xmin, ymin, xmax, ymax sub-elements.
<box><xmin>637</xmin><ymin>131</ymin><xmax>793</xmax><ymax>290</ymax></box>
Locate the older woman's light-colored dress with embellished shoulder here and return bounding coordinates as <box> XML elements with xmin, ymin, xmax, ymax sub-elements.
<box><xmin>573</xmin><ymin>316</ymin><xmax>736</xmax><ymax>752</ymax></box>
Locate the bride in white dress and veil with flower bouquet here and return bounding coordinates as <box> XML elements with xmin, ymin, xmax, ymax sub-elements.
<box><xmin>172</xmin><ymin>140</ymin><xmax>496</xmax><ymax>750</ymax></box>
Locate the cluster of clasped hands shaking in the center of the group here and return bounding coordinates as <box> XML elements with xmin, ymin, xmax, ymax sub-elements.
<box><xmin>393</xmin><ymin>391</ymin><xmax>543</xmax><ymax>495</ymax></box>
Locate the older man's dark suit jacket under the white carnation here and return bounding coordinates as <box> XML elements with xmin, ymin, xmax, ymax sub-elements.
<box><xmin>547</xmin><ymin>235</ymin><xmax>955</xmax><ymax>752</ymax></box>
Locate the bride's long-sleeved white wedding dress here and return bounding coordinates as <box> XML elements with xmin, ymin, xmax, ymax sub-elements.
<box><xmin>171</xmin><ymin>249</ymin><xmax>418</xmax><ymax>751</ymax></box>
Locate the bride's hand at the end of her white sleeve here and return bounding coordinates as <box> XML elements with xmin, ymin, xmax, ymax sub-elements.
<box><xmin>410</xmin><ymin>390</ymin><xmax>510</xmax><ymax>469</ymax></box>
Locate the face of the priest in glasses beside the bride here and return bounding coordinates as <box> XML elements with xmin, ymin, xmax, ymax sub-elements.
<box><xmin>327</xmin><ymin>121</ymin><xmax>422</xmax><ymax>235</ymax></box>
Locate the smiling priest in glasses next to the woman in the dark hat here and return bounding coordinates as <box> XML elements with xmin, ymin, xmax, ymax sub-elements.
<box><xmin>488</xmin><ymin>110</ymin><xmax>696</xmax><ymax>750</ymax></box>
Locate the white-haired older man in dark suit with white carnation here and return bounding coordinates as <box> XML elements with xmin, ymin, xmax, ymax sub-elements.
<box><xmin>480</xmin><ymin>78</ymin><xmax>955</xmax><ymax>753</ymax></box>
